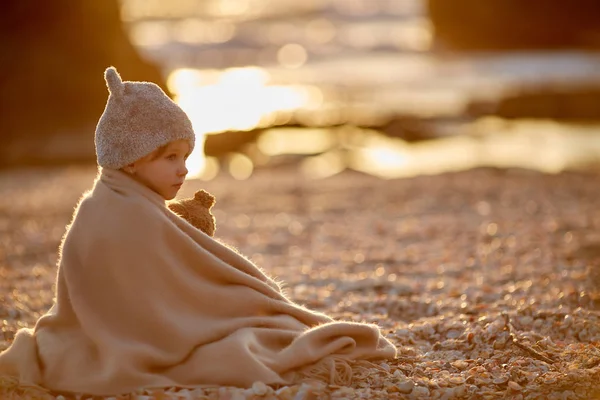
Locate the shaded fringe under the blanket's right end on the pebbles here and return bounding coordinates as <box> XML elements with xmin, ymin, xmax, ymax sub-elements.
<box><xmin>296</xmin><ymin>355</ymin><xmax>383</xmax><ymax>386</ymax></box>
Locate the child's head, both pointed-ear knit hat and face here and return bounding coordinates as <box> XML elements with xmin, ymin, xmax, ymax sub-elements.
<box><xmin>96</xmin><ymin>68</ymin><xmax>195</xmax><ymax>200</ymax></box>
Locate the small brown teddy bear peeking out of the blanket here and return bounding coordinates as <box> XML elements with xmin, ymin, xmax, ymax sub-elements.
<box><xmin>167</xmin><ymin>189</ymin><xmax>217</xmax><ymax>236</ymax></box>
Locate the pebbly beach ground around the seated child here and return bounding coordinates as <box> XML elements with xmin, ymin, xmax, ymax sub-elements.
<box><xmin>0</xmin><ymin>164</ymin><xmax>600</xmax><ymax>400</ymax></box>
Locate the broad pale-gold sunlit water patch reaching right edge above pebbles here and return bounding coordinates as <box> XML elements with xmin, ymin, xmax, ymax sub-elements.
<box><xmin>348</xmin><ymin>118</ymin><xmax>600</xmax><ymax>178</ymax></box>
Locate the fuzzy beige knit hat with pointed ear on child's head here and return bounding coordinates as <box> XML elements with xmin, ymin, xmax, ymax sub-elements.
<box><xmin>95</xmin><ymin>67</ymin><xmax>195</xmax><ymax>169</ymax></box>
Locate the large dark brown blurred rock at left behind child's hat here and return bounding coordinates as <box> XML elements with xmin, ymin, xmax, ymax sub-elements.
<box><xmin>0</xmin><ymin>0</ymin><xmax>165</xmax><ymax>165</ymax></box>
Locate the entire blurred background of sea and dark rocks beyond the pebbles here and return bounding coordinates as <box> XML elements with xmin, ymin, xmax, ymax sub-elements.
<box><xmin>0</xmin><ymin>0</ymin><xmax>600</xmax><ymax>180</ymax></box>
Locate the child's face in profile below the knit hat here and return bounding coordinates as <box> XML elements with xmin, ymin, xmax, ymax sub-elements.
<box><xmin>129</xmin><ymin>140</ymin><xmax>190</xmax><ymax>200</ymax></box>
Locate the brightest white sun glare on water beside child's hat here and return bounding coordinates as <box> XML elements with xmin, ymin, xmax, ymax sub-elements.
<box><xmin>167</xmin><ymin>67</ymin><xmax>322</xmax><ymax>178</ymax></box>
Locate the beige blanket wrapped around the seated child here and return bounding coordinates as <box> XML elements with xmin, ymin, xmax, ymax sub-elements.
<box><xmin>0</xmin><ymin>170</ymin><xmax>396</xmax><ymax>395</ymax></box>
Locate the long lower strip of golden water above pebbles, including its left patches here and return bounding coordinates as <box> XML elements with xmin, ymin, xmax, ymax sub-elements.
<box><xmin>237</xmin><ymin>118</ymin><xmax>600</xmax><ymax>179</ymax></box>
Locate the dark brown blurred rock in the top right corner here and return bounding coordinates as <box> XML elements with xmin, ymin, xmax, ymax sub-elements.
<box><xmin>427</xmin><ymin>0</ymin><xmax>600</xmax><ymax>50</ymax></box>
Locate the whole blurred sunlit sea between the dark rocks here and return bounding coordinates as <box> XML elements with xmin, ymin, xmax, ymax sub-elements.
<box><xmin>122</xmin><ymin>0</ymin><xmax>600</xmax><ymax>179</ymax></box>
